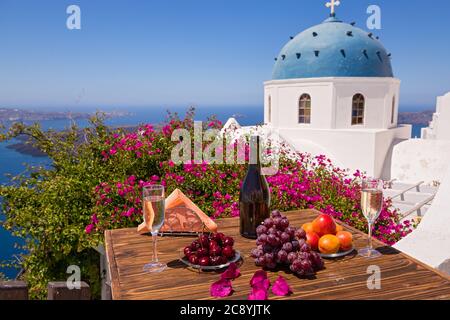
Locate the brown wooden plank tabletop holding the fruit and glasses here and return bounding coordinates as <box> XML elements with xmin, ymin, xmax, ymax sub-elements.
<box><xmin>105</xmin><ymin>210</ymin><xmax>450</xmax><ymax>300</ymax></box>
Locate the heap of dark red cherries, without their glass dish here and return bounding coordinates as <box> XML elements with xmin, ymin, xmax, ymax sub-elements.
<box><xmin>184</xmin><ymin>233</ymin><xmax>236</xmax><ymax>267</ymax></box>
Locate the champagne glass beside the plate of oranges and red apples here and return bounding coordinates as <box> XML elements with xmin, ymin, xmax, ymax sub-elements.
<box><xmin>358</xmin><ymin>179</ymin><xmax>384</xmax><ymax>258</ymax></box>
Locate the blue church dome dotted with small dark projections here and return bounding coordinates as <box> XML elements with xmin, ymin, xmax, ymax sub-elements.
<box><xmin>272</xmin><ymin>16</ymin><xmax>394</xmax><ymax>80</ymax></box>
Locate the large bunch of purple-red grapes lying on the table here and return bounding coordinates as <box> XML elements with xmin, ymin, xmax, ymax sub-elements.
<box><xmin>252</xmin><ymin>211</ymin><xmax>324</xmax><ymax>276</ymax></box>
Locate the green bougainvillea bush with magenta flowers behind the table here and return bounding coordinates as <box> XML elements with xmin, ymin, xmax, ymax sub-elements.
<box><xmin>0</xmin><ymin>110</ymin><xmax>412</xmax><ymax>298</ymax></box>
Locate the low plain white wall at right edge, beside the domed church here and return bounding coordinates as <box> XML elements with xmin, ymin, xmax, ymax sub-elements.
<box><xmin>392</xmin><ymin>139</ymin><xmax>450</xmax><ymax>184</ymax></box>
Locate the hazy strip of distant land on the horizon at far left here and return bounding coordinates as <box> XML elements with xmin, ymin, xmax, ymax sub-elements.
<box><xmin>0</xmin><ymin>108</ymin><xmax>130</xmax><ymax>122</ymax></box>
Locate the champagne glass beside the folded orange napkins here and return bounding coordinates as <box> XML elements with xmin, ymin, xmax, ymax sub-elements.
<box><xmin>142</xmin><ymin>185</ymin><xmax>167</xmax><ymax>273</ymax></box>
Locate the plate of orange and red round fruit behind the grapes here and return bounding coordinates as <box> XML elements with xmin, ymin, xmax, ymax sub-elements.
<box><xmin>302</xmin><ymin>214</ymin><xmax>355</xmax><ymax>259</ymax></box>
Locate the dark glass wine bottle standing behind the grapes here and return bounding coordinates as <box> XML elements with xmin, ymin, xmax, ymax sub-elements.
<box><xmin>239</xmin><ymin>136</ymin><xmax>270</xmax><ymax>239</ymax></box>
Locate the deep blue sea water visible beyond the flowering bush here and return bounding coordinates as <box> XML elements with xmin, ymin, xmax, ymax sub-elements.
<box><xmin>0</xmin><ymin>107</ymin><xmax>423</xmax><ymax>279</ymax></box>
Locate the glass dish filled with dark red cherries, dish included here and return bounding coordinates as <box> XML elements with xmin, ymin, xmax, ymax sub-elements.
<box><xmin>180</xmin><ymin>233</ymin><xmax>241</xmax><ymax>271</ymax></box>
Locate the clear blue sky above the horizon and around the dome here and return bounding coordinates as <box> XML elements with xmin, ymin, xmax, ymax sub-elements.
<box><xmin>0</xmin><ymin>0</ymin><xmax>450</xmax><ymax>109</ymax></box>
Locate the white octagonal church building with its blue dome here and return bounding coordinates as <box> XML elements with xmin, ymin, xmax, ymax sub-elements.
<box><xmin>239</xmin><ymin>14</ymin><xmax>411</xmax><ymax>179</ymax></box>
